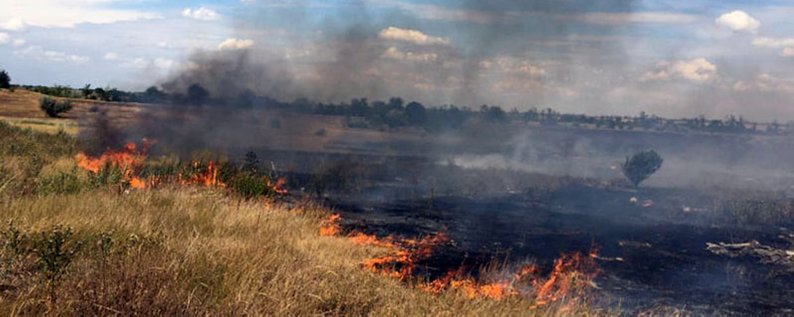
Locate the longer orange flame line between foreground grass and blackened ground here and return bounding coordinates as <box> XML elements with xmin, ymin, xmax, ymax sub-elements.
<box><xmin>320</xmin><ymin>214</ymin><xmax>599</xmax><ymax>306</ymax></box>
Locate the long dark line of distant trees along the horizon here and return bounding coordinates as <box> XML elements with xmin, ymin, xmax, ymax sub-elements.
<box><xmin>23</xmin><ymin>84</ymin><xmax>794</xmax><ymax>135</ymax></box>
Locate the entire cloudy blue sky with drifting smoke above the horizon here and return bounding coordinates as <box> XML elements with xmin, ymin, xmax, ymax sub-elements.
<box><xmin>0</xmin><ymin>0</ymin><xmax>794</xmax><ymax>122</ymax></box>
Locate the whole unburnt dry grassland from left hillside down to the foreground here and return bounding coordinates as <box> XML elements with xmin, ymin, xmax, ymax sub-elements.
<box><xmin>0</xmin><ymin>91</ymin><xmax>607</xmax><ymax>316</ymax></box>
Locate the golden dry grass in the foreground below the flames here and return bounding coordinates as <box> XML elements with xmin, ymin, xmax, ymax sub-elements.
<box><xmin>0</xmin><ymin>187</ymin><xmax>600</xmax><ymax>316</ymax></box>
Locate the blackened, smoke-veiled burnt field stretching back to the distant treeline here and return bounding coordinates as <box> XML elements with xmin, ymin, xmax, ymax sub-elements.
<box><xmin>82</xmin><ymin>107</ymin><xmax>794</xmax><ymax>315</ymax></box>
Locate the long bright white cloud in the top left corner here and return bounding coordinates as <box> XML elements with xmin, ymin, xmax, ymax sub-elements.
<box><xmin>0</xmin><ymin>0</ymin><xmax>159</xmax><ymax>31</ymax></box>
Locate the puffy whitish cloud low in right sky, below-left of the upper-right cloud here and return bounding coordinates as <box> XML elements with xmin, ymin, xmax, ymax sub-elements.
<box><xmin>641</xmin><ymin>58</ymin><xmax>717</xmax><ymax>82</ymax></box>
